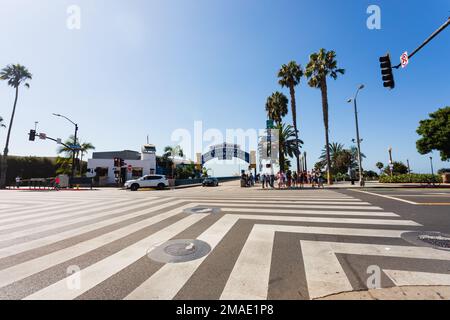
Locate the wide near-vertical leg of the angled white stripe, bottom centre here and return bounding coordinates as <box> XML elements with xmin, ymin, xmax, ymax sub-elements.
<box><xmin>220</xmin><ymin>228</ymin><xmax>275</xmax><ymax>300</ymax></box>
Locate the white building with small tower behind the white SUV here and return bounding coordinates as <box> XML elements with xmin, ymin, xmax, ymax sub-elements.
<box><xmin>87</xmin><ymin>144</ymin><xmax>156</xmax><ymax>186</ymax></box>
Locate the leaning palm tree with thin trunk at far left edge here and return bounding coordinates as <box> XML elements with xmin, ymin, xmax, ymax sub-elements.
<box><xmin>0</xmin><ymin>64</ymin><xmax>33</xmax><ymax>189</ymax></box>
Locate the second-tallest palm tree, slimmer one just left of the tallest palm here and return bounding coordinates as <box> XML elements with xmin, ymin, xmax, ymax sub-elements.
<box><xmin>278</xmin><ymin>61</ymin><xmax>304</xmax><ymax>172</ymax></box>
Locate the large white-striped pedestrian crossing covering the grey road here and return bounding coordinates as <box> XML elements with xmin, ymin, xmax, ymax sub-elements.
<box><xmin>0</xmin><ymin>184</ymin><xmax>450</xmax><ymax>300</ymax></box>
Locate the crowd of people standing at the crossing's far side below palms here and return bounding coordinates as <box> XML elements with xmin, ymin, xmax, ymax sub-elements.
<box><xmin>258</xmin><ymin>170</ymin><xmax>325</xmax><ymax>189</ymax></box>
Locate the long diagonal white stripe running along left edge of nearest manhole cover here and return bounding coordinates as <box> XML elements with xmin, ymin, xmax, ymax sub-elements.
<box><xmin>25</xmin><ymin>214</ymin><xmax>206</xmax><ymax>300</ymax></box>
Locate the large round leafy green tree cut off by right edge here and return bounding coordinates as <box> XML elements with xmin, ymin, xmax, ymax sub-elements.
<box><xmin>417</xmin><ymin>107</ymin><xmax>450</xmax><ymax>161</ymax></box>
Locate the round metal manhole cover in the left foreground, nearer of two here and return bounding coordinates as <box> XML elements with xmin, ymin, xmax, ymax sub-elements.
<box><xmin>147</xmin><ymin>240</ymin><xmax>211</xmax><ymax>263</ymax></box>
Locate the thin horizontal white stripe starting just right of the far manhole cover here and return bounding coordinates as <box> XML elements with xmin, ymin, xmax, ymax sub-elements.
<box><xmin>222</xmin><ymin>208</ymin><xmax>399</xmax><ymax>217</ymax></box>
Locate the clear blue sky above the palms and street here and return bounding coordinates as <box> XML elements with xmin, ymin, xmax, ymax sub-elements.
<box><xmin>0</xmin><ymin>0</ymin><xmax>450</xmax><ymax>175</ymax></box>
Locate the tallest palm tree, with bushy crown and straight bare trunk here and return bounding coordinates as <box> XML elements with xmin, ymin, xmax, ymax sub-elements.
<box><xmin>305</xmin><ymin>49</ymin><xmax>345</xmax><ymax>184</ymax></box>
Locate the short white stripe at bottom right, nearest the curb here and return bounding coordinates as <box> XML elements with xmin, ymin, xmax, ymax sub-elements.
<box><xmin>383</xmin><ymin>270</ymin><xmax>450</xmax><ymax>287</ymax></box>
